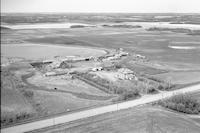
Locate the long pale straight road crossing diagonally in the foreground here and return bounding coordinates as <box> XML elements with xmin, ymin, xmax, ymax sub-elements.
<box><xmin>1</xmin><ymin>84</ymin><xmax>200</xmax><ymax>133</ymax></box>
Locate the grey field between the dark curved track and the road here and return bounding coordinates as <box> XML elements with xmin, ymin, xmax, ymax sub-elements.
<box><xmin>30</xmin><ymin>90</ymin><xmax>109</xmax><ymax>116</ymax></box>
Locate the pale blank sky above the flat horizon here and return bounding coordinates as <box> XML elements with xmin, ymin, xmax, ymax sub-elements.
<box><xmin>1</xmin><ymin>0</ymin><xmax>200</xmax><ymax>13</ymax></box>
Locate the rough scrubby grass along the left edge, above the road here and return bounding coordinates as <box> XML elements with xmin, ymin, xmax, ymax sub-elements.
<box><xmin>1</xmin><ymin>70</ymin><xmax>35</xmax><ymax>126</ymax></box>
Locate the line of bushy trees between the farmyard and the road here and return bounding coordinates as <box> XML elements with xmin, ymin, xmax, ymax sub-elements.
<box><xmin>76</xmin><ymin>73</ymin><xmax>163</xmax><ymax>100</ymax></box>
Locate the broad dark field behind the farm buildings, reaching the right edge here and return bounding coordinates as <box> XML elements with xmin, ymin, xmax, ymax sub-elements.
<box><xmin>27</xmin><ymin>28</ymin><xmax>200</xmax><ymax>67</ymax></box>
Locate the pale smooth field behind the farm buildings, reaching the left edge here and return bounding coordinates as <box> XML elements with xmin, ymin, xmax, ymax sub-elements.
<box><xmin>1</xmin><ymin>44</ymin><xmax>106</xmax><ymax>60</ymax></box>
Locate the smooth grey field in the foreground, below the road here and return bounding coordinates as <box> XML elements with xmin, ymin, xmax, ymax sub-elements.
<box><xmin>31</xmin><ymin>106</ymin><xmax>200</xmax><ymax>133</ymax></box>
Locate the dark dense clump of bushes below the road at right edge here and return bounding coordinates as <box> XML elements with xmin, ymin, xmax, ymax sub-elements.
<box><xmin>158</xmin><ymin>94</ymin><xmax>200</xmax><ymax>114</ymax></box>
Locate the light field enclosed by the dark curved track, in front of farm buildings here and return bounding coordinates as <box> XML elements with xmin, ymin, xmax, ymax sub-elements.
<box><xmin>28</xmin><ymin>74</ymin><xmax>107</xmax><ymax>96</ymax></box>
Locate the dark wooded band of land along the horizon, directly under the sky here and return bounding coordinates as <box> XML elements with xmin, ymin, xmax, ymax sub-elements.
<box><xmin>2</xmin><ymin>13</ymin><xmax>200</xmax><ymax>25</ymax></box>
